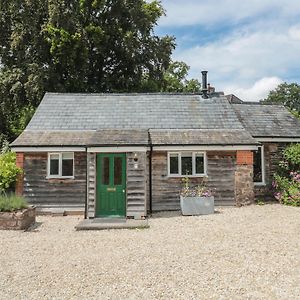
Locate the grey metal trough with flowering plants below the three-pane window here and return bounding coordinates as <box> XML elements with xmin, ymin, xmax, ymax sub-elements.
<box><xmin>180</xmin><ymin>177</ymin><xmax>215</xmax><ymax>216</ymax></box>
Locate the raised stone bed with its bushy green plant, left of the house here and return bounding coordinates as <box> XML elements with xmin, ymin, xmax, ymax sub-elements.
<box><xmin>0</xmin><ymin>193</ymin><xmax>36</xmax><ymax>230</ymax></box>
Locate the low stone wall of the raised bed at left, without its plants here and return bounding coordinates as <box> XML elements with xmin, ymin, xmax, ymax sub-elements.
<box><xmin>0</xmin><ymin>206</ymin><xmax>36</xmax><ymax>230</ymax></box>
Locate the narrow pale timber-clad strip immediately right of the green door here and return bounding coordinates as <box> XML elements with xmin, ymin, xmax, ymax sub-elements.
<box><xmin>127</xmin><ymin>152</ymin><xmax>147</xmax><ymax>218</ymax></box>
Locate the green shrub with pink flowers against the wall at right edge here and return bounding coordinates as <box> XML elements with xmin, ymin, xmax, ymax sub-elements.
<box><xmin>273</xmin><ymin>144</ymin><xmax>300</xmax><ymax>206</ymax></box>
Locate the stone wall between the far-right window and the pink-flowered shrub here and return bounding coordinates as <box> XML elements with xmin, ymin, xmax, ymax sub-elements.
<box><xmin>254</xmin><ymin>143</ymin><xmax>288</xmax><ymax>200</ymax></box>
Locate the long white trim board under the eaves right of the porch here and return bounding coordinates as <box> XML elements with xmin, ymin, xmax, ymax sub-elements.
<box><xmin>153</xmin><ymin>145</ymin><xmax>258</xmax><ymax>152</ymax></box>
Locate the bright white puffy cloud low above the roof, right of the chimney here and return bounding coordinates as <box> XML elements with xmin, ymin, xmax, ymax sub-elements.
<box><xmin>224</xmin><ymin>77</ymin><xmax>283</xmax><ymax>101</ymax></box>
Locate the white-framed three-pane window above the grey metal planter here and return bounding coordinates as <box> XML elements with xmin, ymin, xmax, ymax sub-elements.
<box><xmin>168</xmin><ymin>152</ymin><xmax>206</xmax><ymax>177</ymax></box>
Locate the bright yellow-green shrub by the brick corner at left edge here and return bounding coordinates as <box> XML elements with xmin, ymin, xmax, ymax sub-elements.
<box><xmin>0</xmin><ymin>152</ymin><xmax>22</xmax><ymax>193</ymax></box>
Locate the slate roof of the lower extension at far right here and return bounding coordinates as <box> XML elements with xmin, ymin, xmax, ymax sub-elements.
<box><xmin>232</xmin><ymin>103</ymin><xmax>300</xmax><ymax>138</ymax></box>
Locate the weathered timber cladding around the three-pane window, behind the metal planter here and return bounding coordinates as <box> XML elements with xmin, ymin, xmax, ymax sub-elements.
<box><xmin>152</xmin><ymin>151</ymin><xmax>236</xmax><ymax>211</ymax></box>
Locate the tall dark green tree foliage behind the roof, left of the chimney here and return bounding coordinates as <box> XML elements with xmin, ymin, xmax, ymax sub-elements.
<box><xmin>0</xmin><ymin>0</ymin><xmax>199</xmax><ymax>143</ymax></box>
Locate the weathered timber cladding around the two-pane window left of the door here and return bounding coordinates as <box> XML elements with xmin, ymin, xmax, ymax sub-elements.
<box><xmin>24</xmin><ymin>152</ymin><xmax>86</xmax><ymax>211</ymax></box>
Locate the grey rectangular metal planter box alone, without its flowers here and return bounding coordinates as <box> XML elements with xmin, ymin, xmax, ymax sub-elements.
<box><xmin>180</xmin><ymin>196</ymin><xmax>215</xmax><ymax>216</ymax></box>
